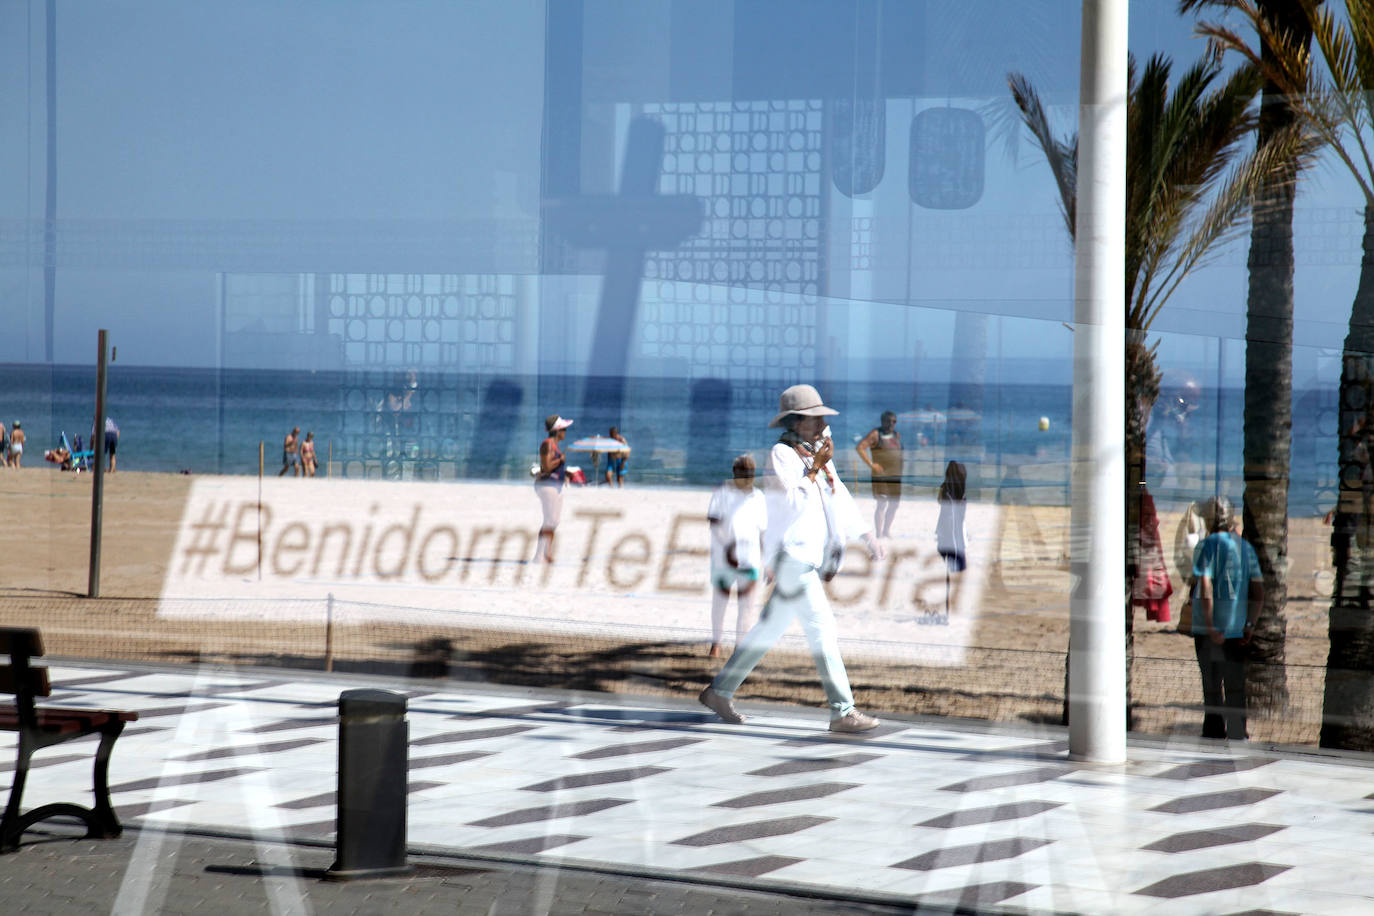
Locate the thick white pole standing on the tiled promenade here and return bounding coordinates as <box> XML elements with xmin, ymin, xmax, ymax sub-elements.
<box><xmin>1069</xmin><ymin>0</ymin><xmax>1127</xmax><ymax>764</ymax></box>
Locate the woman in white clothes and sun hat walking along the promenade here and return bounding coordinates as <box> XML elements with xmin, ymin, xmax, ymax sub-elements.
<box><xmin>699</xmin><ymin>385</ymin><xmax>883</xmax><ymax>732</ymax></box>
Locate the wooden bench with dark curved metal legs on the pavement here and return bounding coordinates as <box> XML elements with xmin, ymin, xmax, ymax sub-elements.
<box><xmin>0</xmin><ymin>628</ymin><xmax>139</xmax><ymax>853</ymax></box>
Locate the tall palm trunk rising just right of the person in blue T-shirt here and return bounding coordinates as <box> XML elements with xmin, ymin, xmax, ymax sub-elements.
<box><xmin>1179</xmin><ymin>0</ymin><xmax>1312</xmax><ymax>713</ymax></box>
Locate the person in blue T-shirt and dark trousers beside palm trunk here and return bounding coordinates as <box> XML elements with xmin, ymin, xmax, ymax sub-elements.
<box><xmin>1193</xmin><ymin>496</ymin><xmax>1264</xmax><ymax>742</ymax></box>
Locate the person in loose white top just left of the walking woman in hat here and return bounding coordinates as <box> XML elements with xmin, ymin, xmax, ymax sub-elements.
<box><xmin>706</xmin><ymin>455</ymin><xmax>768</xmax><ymax>658</ymax></box>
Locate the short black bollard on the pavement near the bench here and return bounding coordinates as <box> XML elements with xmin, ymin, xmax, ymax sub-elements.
<box><xmin>327</xmin><ymin>689</ymin><xmax>414</xmax><ymax>880</ymax></box>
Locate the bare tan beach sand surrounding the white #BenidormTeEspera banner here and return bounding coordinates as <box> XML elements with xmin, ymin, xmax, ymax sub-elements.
<box><xmin>0</xmin><ymin>467</ymin><xmax>1331</xmax><ymax>744</ymax></box>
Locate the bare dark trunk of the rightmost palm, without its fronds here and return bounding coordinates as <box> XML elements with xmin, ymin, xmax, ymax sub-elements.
<box><xmin>1322</xmin><ymin>203</ymin><xmax>1374</xmax><ymax>751</ymax></box>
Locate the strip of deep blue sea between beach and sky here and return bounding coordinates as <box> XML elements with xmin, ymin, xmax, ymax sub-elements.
<box><xmin>0</xmin><ymin>364</ymin><xmax>1337</xmax><ymax>515</ymax></box>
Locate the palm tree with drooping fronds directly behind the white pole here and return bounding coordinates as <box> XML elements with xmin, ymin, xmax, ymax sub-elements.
<box><xmin>1007</xmin><ymin>55</ymin><xmax>1303</xmax><ymax>721</ymax></box>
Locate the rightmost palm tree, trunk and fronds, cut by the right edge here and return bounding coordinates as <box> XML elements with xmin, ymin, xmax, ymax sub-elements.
<box><xmin>1198</xmin><ymin>0</ymin><xmax>1374</xmax><ymax>750</ymax></box>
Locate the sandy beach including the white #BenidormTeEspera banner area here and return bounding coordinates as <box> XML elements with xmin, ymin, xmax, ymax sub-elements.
<box><xmin>0</xmin><ymin>467</ymin><xmax>1331</xmax><ymax>744</ymax></box>
